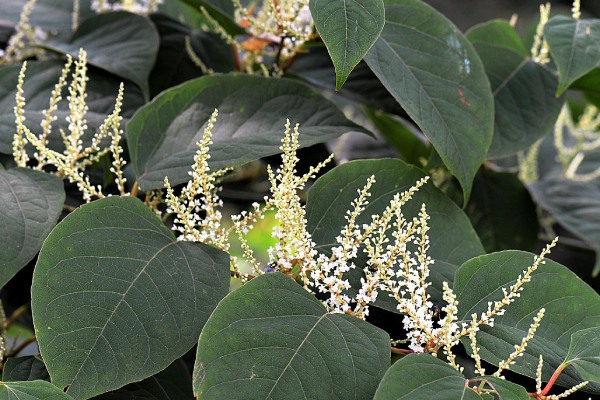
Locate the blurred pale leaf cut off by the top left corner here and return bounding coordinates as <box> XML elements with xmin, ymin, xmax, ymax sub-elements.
<box><xmin>0</xmin><ymin>0</ymin><xmax>94</xmax><ymax>32</ymax></box>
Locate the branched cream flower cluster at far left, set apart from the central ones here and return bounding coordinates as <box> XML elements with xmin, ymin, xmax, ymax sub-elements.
<box><xmin>13</xmin><ymin>50</ymin><xmax>126</xmax><ymax>202</ymax></box>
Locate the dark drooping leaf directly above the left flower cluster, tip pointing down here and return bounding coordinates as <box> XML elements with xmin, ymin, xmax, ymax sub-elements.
<box><xmin>48</xmin><ymin>12</ymin><xmax>159</xmax><ymax>97</ymax></box>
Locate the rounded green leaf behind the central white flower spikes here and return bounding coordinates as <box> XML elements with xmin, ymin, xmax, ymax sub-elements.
<box><xmin>306</xmin><ymin>159</ymin><xmax>484</xmax><ymax>311</ymax></box>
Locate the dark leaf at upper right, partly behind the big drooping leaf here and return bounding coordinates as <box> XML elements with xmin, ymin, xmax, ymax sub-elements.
<box><xmin>467</xmin><ymin>20</ymin><xmax>565</xmax><ymax>158</ymax></box>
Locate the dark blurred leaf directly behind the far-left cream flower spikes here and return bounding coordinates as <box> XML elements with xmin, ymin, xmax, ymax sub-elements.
<box><xmin>0</xmin><ymin>61</ymin><xmax>144</xmax><ymax>154</ymax></box>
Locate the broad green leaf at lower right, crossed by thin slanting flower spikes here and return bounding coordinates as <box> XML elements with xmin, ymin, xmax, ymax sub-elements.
<box><xmin>454</xmin><ymin>250</ymin><xmax>600</xmax><ymax>393</ymax></box>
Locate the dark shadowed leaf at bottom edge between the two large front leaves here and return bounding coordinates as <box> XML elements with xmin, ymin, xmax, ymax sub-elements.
<box><xmin>93</xmin><ymin>359</ymin><xmax>194</xmax><ymax>400</ymax></box>
